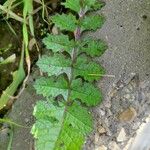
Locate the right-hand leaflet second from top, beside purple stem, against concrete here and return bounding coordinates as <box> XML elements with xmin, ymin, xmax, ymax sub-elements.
<box><xmin>81</xmin><ymin>15</ymin><xmax>105</xmax><ymax>31</ymax></box>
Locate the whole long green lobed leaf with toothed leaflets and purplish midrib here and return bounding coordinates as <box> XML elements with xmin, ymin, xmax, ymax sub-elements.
<box><xmin>31</xmin><ymin>0</ymin><xmax>107</xmax><ymax>150</ymax></box>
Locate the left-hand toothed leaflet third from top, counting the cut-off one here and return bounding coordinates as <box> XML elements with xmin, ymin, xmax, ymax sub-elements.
<box><xmin>43</xmin><ymin>34</ymin><xmax>74</xmax><ymax>53</ymax></box>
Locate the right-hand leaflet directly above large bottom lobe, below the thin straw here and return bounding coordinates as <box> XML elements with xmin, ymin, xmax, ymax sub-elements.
<box><xmin>71</xmin><ymin>79</ymin><xmax>102</xmax><ymax>106</ymax></box>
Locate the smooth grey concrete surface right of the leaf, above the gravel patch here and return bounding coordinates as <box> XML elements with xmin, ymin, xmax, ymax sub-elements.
<box><xmin>96</xmin><ymin>0</ymin><xmax>150</xmax><ymax>95</ymax></box>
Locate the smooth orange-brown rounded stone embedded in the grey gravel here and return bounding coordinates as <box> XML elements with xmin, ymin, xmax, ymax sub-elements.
<box><xmin>118</xmin><ymin>107</ymin><xmax>137</xmax><ymax>122</ymax></box>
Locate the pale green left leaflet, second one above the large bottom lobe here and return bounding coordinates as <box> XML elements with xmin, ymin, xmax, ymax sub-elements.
<box><xmin>37</xmin><ymin>53</ymin><xmax>71</xmax><ymax>78</ymax></box>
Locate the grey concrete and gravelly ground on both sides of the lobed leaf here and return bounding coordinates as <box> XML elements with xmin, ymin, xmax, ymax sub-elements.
<box><xmin>0</xmin><ymin>0</ymin><xmax>150</xmax><ymax>150</ymax></box>
